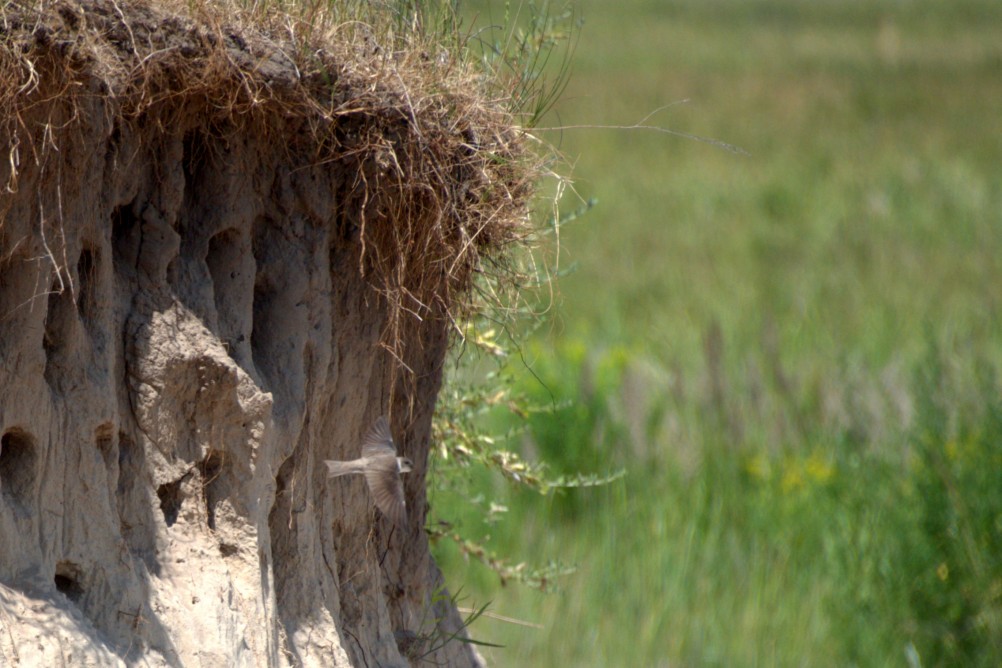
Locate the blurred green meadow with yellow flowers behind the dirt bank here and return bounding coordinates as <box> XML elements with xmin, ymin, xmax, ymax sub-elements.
<box><xmin>432</xmin><ymin>0</ymin><xmax>1002</xmax><ymax>667</ymax></box>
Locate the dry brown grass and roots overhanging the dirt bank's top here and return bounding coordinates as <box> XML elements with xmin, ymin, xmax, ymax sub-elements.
<box><xmin>0</xmin><ymin>0</ymin><xmax>541</xmax><ymax>376</ymax></box>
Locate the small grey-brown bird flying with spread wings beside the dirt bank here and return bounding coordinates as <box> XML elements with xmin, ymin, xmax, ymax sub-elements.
<box><xmin>324</xmin><ymin>416</ymin><xmax>414</xmax><ymax>527</ymax></box>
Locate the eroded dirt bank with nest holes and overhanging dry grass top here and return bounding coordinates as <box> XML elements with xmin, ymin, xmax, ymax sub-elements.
<box><xmin>0</xmin><ymin>2</ymin><xmax>527</xmax><ymax>666</ymax></box>
